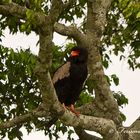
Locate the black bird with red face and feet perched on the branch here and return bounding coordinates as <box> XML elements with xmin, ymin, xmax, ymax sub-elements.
<box><xmin>52</xmin><ymin>46</ymin><xmax>88</xmax><ymax>116</ymax></box>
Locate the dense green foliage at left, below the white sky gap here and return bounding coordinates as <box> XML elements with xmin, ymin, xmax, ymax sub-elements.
<box><xmin>0</xmin><ymin>46</ymin><xmax>41</xmax><ymax>139</ymax></box>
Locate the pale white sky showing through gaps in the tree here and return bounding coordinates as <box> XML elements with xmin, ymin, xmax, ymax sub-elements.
<box><xmin>2</xmin><ymin>29</ymin><xmax>140</xmax><ymax>140</ymax></box>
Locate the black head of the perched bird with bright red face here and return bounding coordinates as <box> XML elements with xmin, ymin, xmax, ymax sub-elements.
<box><xmin>70</xmin><ymin>46</ymin><xmax>88</xmax><ymax>63</ymax></box>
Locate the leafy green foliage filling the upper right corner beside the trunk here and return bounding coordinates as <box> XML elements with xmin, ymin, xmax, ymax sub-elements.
<box><xmin>103</xmin><ymin>0</ymin><xmax>140</xmax><ymax>70</ymax></box>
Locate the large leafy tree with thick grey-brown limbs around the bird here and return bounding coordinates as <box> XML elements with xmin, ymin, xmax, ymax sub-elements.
<box><xmin>0</xmin><ymin>0</ymin><xmax>140</xmax><ymax>140</ymax></box>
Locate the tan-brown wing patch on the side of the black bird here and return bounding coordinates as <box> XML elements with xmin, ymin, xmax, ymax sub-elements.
<box><xmin>52</xmin><ymin>62</ymin><xmax>70</xmax><ymax>84</ymax></box>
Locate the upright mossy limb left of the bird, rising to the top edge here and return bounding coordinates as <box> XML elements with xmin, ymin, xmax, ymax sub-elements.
<box><xmin>35</xmin><ymin>0</ymin><xmax>64</xmax><ymax>115</ymax></box>
